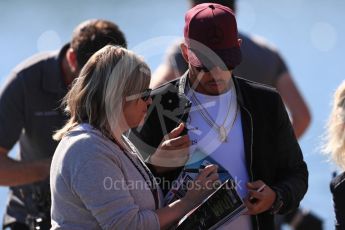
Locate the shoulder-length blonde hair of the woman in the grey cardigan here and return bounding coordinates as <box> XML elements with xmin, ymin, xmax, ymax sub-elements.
<box><xmin>54</xmin><ymin>45</ymin><xmax>151</xmax><ymax>140</ymax></box>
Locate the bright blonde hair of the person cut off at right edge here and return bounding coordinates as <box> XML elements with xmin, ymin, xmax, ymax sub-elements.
<box><xmin>324</xmin><ymin>81</ymin><xmax>345</xmax><ymax>169</ymax></box>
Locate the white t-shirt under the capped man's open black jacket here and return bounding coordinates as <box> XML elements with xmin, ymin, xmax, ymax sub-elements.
<box><xmin>187</xmin><ymin>89</ymin><xmax>252</xmax><ymax>230</ymax></box>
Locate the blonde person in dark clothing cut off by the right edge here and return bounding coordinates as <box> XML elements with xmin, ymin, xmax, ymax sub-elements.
<box><xmin>325</xmin><ymin>81</ymin><xmax>345</xmax><ymax>229</ymax></box>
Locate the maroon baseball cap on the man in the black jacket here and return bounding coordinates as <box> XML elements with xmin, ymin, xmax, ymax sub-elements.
<box><xmin>184</xmin><ymin>3</ymin><xmax>242</xmax><ymax>69</ymax></box>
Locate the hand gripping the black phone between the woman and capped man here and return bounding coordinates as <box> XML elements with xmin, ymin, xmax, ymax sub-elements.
<box><xmin>149</xmin><ymin>123</ymin><xmax>191</xmax><ymax>171</ymax></box>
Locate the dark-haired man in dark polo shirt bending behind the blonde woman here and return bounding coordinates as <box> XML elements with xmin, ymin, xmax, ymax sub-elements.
<box><xmin>0</xmin><ymin>19</ymin><xmax>127</xmax><ymax>229</ymax></box>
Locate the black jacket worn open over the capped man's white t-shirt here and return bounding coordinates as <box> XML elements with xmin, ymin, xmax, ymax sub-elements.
<box><xmin>130</xmin><ymin>73</ymin><xmax>308</xmax><ymax>230</ymax></box>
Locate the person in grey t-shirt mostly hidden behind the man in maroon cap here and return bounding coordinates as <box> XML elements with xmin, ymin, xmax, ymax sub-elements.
<box><xmin>151</xmin><ymin>0</ymin><xmax>311</xmax><ymax>138</ymax></box>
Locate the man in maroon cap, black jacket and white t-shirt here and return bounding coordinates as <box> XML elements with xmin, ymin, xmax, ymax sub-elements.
<box><xmin>129</xmin><ymin>3</ymin><xmax>308</xmax><ymax>230</ymax></box>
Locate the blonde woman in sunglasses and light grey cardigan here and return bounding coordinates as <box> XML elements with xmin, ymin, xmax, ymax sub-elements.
<box><xmin>50</xmin><ymin>46</ymin><xmax>218</xmax><ymax>230</ymax></box>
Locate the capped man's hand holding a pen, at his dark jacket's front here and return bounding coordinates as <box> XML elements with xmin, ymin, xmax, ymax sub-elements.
<box><xmin>244</xmin><ymin>180</ymin><xmax>276</xmax><ymax>215</ymax></box>
